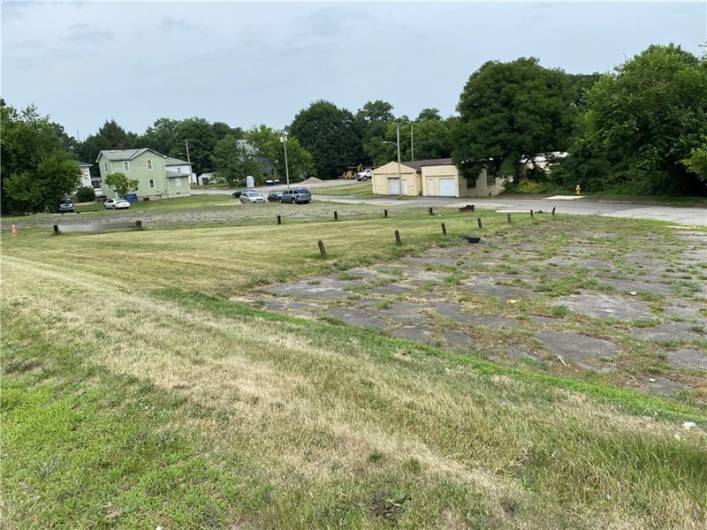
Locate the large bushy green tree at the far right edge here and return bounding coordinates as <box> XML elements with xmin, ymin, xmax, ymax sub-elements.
<box><xmin>553</xmin><ymin>45</ymin><xmax>707</xmax><ymax>194</ymax></box>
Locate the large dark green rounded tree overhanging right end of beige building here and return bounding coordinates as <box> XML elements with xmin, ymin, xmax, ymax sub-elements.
<box><xmin>452</xmin><ymin>57</ymin><xmax>576</xmax><ymax>180</ymax></box>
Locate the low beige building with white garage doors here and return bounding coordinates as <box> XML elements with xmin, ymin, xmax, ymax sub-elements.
<box><xmin>372</xmin><ymin>158</ymin><xmax>505</xmax><ymax>197</ymax></box>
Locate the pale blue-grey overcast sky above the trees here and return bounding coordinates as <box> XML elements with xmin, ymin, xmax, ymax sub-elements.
<box><xmin>0</xmin><ymin>0</ymin><xmax>707</xmax><ymax>138</ymax></box>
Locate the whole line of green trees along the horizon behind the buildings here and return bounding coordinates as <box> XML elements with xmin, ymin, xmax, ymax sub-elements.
<box><xmin>2</xmin><ymin>45</ymin><xmax>707</xmax><ymax>211</ymax></box>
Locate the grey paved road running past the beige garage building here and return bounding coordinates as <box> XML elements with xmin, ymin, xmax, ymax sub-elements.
<box><xmin>192</xmin><ymin>186</ymin><xmax>707</xmax><ymax>226</ymax></box>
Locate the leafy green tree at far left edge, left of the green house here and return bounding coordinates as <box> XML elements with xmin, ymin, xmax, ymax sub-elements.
<box><xmin>0</xmin><ymin>102</ymin><xmax>80</xmax><ymax>213</ymax></box>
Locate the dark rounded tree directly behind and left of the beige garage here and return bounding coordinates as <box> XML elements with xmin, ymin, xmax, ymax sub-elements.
<box><xmin>288</xmin><ymin>101</ymin><xmax>363</xmax><ymax>178</ymax></box>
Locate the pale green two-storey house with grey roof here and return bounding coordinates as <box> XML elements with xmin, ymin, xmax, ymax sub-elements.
<box><xmin>96</xmin><ymin>148</ymin><xmax>191</xmax><ymax>199</ymax></box>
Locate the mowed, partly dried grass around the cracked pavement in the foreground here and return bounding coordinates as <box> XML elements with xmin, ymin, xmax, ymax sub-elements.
<box><xmin>0</xmin><ymin>204</ymin><xmax>707</xmax><ymax>528</ymax></box>
